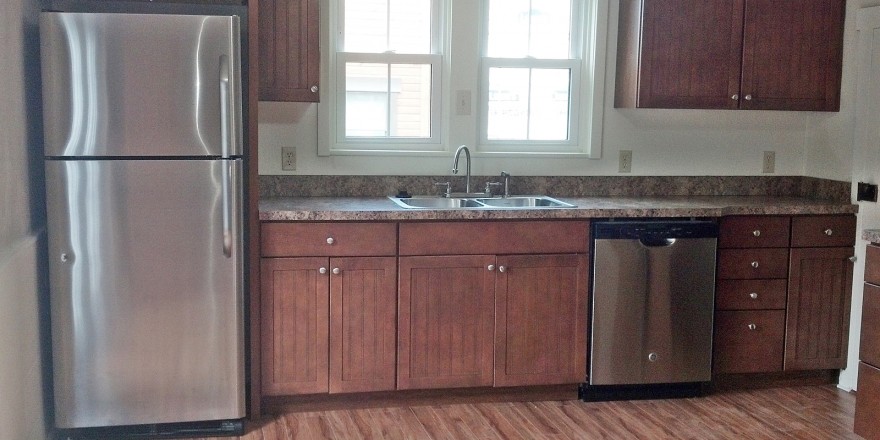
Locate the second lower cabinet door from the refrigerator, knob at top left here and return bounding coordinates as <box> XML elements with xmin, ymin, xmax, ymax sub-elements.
<box><xmin>330</xmin><ymin>257</ymin><xmax>397</xmax><ymax>393</ymax></box>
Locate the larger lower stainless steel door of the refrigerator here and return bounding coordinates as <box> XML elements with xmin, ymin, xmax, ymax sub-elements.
<box><xmin>46</xmin><ymin>160</ymin><xmax>245</xmax><ymax>428</ymax></box>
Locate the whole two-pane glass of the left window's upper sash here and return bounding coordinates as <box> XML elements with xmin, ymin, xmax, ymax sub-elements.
<box><xmin>343</xmin><ymin>0</ymin><xmax>431</xmax><ymax>54</ymax></box>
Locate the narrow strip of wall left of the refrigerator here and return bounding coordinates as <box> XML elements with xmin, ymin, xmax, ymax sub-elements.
<box><xmin>0</xmin><ymin>0</ymin><xmax>46</xmax><ymax>440</ymax></box>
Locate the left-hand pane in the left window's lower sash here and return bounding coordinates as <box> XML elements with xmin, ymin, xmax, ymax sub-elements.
<box><xmin>345</xmin><ymin>63</ymin><xmax>388</xmax><ymax>137</ymax></box>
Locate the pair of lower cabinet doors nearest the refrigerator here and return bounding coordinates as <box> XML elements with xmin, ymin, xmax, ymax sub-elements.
<box><xmin>260</xmin><ymin>257</ymin><xmax>396</xmax><ymax>396</ymax></box>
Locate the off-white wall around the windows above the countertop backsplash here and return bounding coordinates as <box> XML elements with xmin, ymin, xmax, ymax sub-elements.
<box><xmin>259</xmin><ymin>0</ymin><xmax>869</xmax><ymax>180</ymax></box>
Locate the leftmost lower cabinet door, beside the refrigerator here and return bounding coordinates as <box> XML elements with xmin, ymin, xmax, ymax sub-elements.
<box><xmin>260</xmin><ymin>258</ymin><xmax>330</xmax><ymax>396</ymax></box>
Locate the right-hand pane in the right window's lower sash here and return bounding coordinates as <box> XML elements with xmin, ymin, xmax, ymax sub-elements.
<box><xmin>529</xmin><ymin>69</ymin><xmax>571</xmax><ymax>141</ymax></box>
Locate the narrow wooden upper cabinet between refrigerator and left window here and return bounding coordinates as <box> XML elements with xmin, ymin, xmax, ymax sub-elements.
<box><xmin>258</xmin><ymin>0</ymin><xmax>321</xmax><ymax>102</ymax></box>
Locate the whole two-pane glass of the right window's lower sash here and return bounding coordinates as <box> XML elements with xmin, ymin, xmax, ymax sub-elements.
<box><xmin>487</xmin><ymin>67</ymin><xmax>571</xmax><ymax>141</ymax></box>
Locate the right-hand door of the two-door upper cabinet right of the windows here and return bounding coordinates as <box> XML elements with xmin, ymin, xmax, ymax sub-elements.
<box><xmin>741</xmin><ymin>0</ymin><xmax>846</xmax><ymax>111</ymax></box>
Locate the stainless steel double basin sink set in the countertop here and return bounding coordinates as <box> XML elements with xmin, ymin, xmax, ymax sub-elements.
<box><xmin>388</xmin><ymin>196</ymin><xmax>576</xmax><ymax>209</ymax></box>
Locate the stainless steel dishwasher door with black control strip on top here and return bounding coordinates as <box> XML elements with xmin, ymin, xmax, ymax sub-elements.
<box><xmin>589</xmin><ymin>221</ymin><xmax>718</xmax><ymax>385</ymax></box>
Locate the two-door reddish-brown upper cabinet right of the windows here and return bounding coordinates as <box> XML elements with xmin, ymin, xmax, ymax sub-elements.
<box><xmin>615</xmin><ymin>0</ymin><xmax>845</xmax><ymax>111</ymax></box>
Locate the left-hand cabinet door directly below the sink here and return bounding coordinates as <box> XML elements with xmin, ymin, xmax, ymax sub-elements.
<box><xmin>397</xmin><ymin>255</ymin><xmax>495</xmax><ymax>389</ymax></box>
